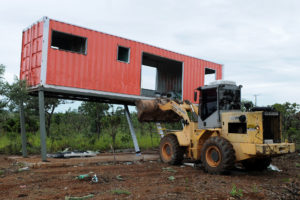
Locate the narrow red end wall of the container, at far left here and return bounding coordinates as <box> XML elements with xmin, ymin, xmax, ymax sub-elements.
<box><xmin>20</xmin><ymin>21</ymin><xmax>43</xmax><ymax>86</ymax></box>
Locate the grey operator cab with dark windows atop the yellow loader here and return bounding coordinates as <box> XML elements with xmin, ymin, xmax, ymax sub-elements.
<box><xmin>195</xmin><ymin>80</ymin><xmax>242</xmax><ymax>129</ymax></box>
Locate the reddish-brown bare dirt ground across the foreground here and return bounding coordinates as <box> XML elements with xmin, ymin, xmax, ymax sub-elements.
<box><xmin>0</xmin><ymin>153</ymin><xmax>300</xmax><ymax>199</ymax></box>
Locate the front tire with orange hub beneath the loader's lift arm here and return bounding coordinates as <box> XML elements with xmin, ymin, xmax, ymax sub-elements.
<box><xmin>159</xmin><ymin>135</ymin><xmax>185</xmax><ymax>165</ymax></box>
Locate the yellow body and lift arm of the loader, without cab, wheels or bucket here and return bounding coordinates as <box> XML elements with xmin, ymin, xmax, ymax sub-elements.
<box><xmin>138</xmin><ymin>100</ymin><xmax>295</xmax><ymax>162</ymax></box>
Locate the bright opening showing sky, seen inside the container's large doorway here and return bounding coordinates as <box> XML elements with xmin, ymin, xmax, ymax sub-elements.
<box><xmin>141</xmin><ymin>65</ymin><xmax>157</xmax><ymax>90</ymax></box>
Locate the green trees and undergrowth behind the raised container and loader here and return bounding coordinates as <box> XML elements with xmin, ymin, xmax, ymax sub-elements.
<box><xmin>0</xmin><ymin>65</ymin><xmax>300</xmax><ymax>154</ymax></box>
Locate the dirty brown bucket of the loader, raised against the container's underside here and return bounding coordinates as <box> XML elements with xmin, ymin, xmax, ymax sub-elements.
<box><xmin>135</xmin><ymin>99</ymin><xmax>181</xmax><ymax>122</ymax></box>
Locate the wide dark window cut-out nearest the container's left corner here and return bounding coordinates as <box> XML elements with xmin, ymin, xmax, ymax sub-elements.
<box><xmin>51</xmin><ymin>31</ymin><xmax>87</xmax><ymax>54</ymax></box>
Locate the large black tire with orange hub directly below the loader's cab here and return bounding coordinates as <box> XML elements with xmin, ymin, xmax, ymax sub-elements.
<box><xmin>201</xmin><ymin>136</ymin><xmax>235</xmax><ymax>174</ymax></box>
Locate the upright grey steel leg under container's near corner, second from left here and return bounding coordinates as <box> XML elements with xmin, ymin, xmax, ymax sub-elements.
<box><xmin>39</xmin><ymin>88</ymin><xmax>47</xmax><ymax>162</ymax></box>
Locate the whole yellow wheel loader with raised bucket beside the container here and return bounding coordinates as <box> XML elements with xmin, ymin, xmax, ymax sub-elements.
<box><xmin>136</xmin><ymin>81</ymin><xmax>295</xmax><ymax>174</ymax></box>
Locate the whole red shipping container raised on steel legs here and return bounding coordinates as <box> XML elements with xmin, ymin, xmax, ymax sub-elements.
<box><xmin>20</xmin><ymin>17</ymin><xmax>222</xmax><ymax>104</ymax></box>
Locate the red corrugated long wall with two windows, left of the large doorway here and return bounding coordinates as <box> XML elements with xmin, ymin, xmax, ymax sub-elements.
<box><xmin>46</xmin><ymin>20</ymin><xmax>141</xmax><ymax>95</ymax></box>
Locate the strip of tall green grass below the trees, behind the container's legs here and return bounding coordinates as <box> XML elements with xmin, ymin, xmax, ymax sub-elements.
<box><xmin>0</xmin><ymin>132</ymin><xmax>160</xmax><ymax>154</ymax></box>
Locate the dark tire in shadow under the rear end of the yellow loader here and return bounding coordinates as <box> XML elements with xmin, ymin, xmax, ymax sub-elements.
<box><xmin>242</xmin><ymin>157</ymin><xmax>272</xmax><ymax>171</ymax></box>
